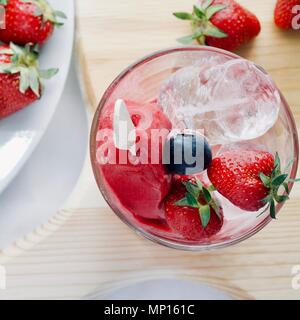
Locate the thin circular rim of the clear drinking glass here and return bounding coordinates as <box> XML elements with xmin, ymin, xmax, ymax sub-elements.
<box><xmin>90</xmin><ymin>45</ymin><xmax>299</xmax><ymax>252</ymax></box>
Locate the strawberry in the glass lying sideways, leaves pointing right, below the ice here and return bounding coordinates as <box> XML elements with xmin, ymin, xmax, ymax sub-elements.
<box><xmin>208</xmin><ymin>150</ymin><xmax>289</xmax><ymax>218</ymax></box>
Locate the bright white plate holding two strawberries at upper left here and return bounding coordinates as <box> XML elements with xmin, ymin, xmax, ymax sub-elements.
<box><xmin>0</xmin><ymin>0</ymin><xmax>74</xmax><ymax>193</ymax></box>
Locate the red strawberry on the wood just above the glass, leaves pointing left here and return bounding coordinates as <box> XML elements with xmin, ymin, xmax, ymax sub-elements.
<box><xmin>174</xmin><ymin>0</ymin><xmax>261</xmax><ymax>50</ymax></box>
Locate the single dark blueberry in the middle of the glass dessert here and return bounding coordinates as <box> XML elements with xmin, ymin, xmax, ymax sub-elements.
<box><xmin>163</xmin><ymin>132</ymin><xmax>212</xmax><ymax>175</ymax></box>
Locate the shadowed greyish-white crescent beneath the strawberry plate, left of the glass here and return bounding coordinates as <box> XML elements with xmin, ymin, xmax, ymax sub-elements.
<box><xmin>0</xmin><ymin>61</ymin><xmax>88</xmax><ymax>250</ymax></box>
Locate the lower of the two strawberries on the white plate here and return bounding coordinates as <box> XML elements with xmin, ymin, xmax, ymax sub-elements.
<box><xmin>0</xmin><ymin>43</ymin><xmax>58</xmax><ymax>119</ymax></box>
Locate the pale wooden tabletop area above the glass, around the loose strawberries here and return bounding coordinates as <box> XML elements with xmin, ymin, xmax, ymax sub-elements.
<box><xmin>77</xmin><ymin>0</ymin><xmax>300</xmax><ymax>121</ymax></box>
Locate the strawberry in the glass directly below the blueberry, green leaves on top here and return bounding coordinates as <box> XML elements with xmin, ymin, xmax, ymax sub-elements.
<box><xmin>165</xmin><ymin>179</ymin><xmax>223</xmax><ymax>241</ymax></box>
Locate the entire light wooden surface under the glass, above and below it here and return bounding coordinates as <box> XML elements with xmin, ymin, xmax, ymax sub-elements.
<box><xmin>0</xmin><ymin>0</ymin><xmax>300</xmax><ymax>299</ymax></box>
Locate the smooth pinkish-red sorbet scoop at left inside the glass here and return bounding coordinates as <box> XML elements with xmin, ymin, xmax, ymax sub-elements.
<box><xmin>97</xmin><ymin>101</ymin><xmax>172</xmax><ymax>219</ymax></box>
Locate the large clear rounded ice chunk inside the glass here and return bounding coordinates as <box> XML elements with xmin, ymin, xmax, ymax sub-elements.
<box><xmin>158</xmin><ymin>59</ymin><xmax>281</xmax><ymax>145</ymax></box>
